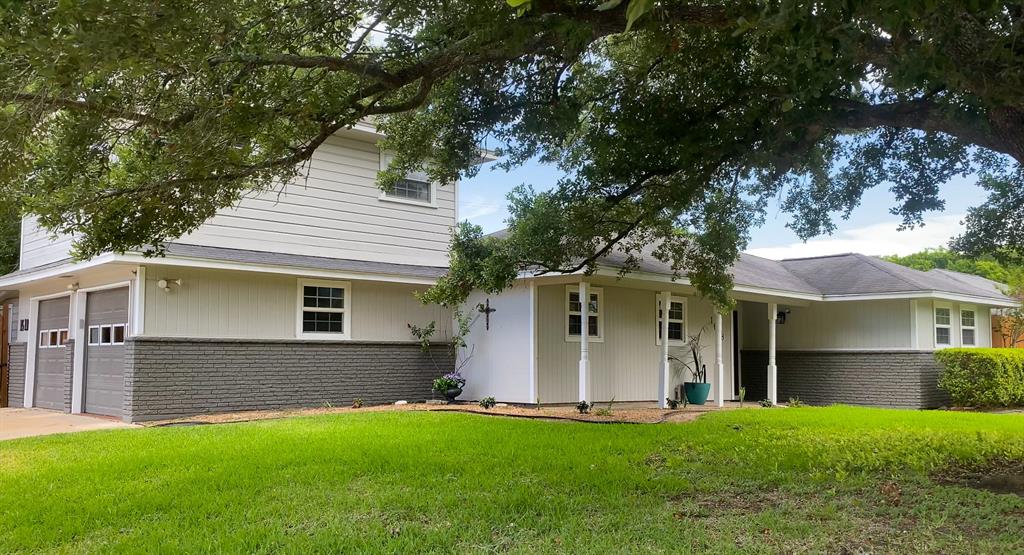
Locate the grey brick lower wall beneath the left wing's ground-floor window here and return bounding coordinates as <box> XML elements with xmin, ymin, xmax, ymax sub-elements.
<box><xmin>124</xmin><ymin>337</ymin><xmax>455</xmax><ymax>422</ymax></box>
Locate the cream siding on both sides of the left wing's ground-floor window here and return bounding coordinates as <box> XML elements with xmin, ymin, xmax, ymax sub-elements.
<box><xmin>144</xmin><ymin>265</ymin><xmax>451</xmax><ymax>341</ymax></box>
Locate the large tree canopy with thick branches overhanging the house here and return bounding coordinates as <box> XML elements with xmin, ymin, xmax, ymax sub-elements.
<box><xmin>0</xmin><ymin>0</ymin><xmax>1024</xmax><ymax>304</ymax></box>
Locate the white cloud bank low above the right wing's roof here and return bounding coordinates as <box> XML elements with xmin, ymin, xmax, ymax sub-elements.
<box><xmin>748</xmin><ymin>214</ymin><xmax>964</xmax><ymax>260</ymax></box>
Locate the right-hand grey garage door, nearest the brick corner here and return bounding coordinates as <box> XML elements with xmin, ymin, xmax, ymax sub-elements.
<box><xmin>85</xmin><ymin>288</ymin><xmax>128</xmax><ymax>417</ymax></box>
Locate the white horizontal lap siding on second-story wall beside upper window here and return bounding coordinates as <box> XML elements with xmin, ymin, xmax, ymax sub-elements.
<box><xmin>179</xmin><ymin>136</ymin><xmax>456</xmax><ymax>265</ymax></box>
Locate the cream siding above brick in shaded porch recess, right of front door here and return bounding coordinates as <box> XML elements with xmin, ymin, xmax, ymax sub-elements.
<box><xmin>740</xmin><ymin>299</ymin><xmax>911</xmax><ymax>350</ymax></box>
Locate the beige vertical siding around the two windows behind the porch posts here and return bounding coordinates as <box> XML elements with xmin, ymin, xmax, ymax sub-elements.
<box><xmin>537</xmin><ymin>285</ymin><xmax>732</xmax><ymax>402</ymax></box>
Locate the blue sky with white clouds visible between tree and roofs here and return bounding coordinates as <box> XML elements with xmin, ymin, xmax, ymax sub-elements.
<box><xmin>459</xmin><ymin>156</ymin><xmax>985</xmax><ymax>260</ymax></box>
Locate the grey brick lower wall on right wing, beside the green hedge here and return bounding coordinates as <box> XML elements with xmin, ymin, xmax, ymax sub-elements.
<box><xmin>740</xmin><ymin>350</ymin><xmax>949</xmax><ymax>409</ymax></box>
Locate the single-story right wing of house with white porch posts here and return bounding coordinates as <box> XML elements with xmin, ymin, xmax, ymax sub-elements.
<box><xmin>464</xmin><ymin>241</ymin><xmax>1014</xmax><ymax>408</ymax></box>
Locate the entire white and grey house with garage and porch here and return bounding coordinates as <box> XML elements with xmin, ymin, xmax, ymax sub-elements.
<box><xmin>0</xmin><ymin>126</ymin><xmax>1016</xmax><ymax>421</ymax></box>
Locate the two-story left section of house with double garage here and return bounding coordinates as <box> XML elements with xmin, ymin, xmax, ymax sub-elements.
<box><xmin>0</xmin><ymin>125</ymin><xmax>458</xmax><ymax>421</ymax></box>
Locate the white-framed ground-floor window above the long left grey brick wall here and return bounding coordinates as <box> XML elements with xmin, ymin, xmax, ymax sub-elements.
<box><xmin>296</xmin><ymin>280</ymin><xmax>351</xmax><ymax>339</ymax></box>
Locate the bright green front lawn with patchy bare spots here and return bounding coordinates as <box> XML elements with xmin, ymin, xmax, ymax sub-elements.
<box><xmin>0</xmin><ymin>408</ymin><xmax>1024</xmax><ymax>553</ymax></box>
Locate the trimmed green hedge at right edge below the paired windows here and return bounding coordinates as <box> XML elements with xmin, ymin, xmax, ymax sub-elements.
<box><xmin>935</xmin><ymin>348</ymin><xmax>1024</xmax><ymax>407</ymax></box>
